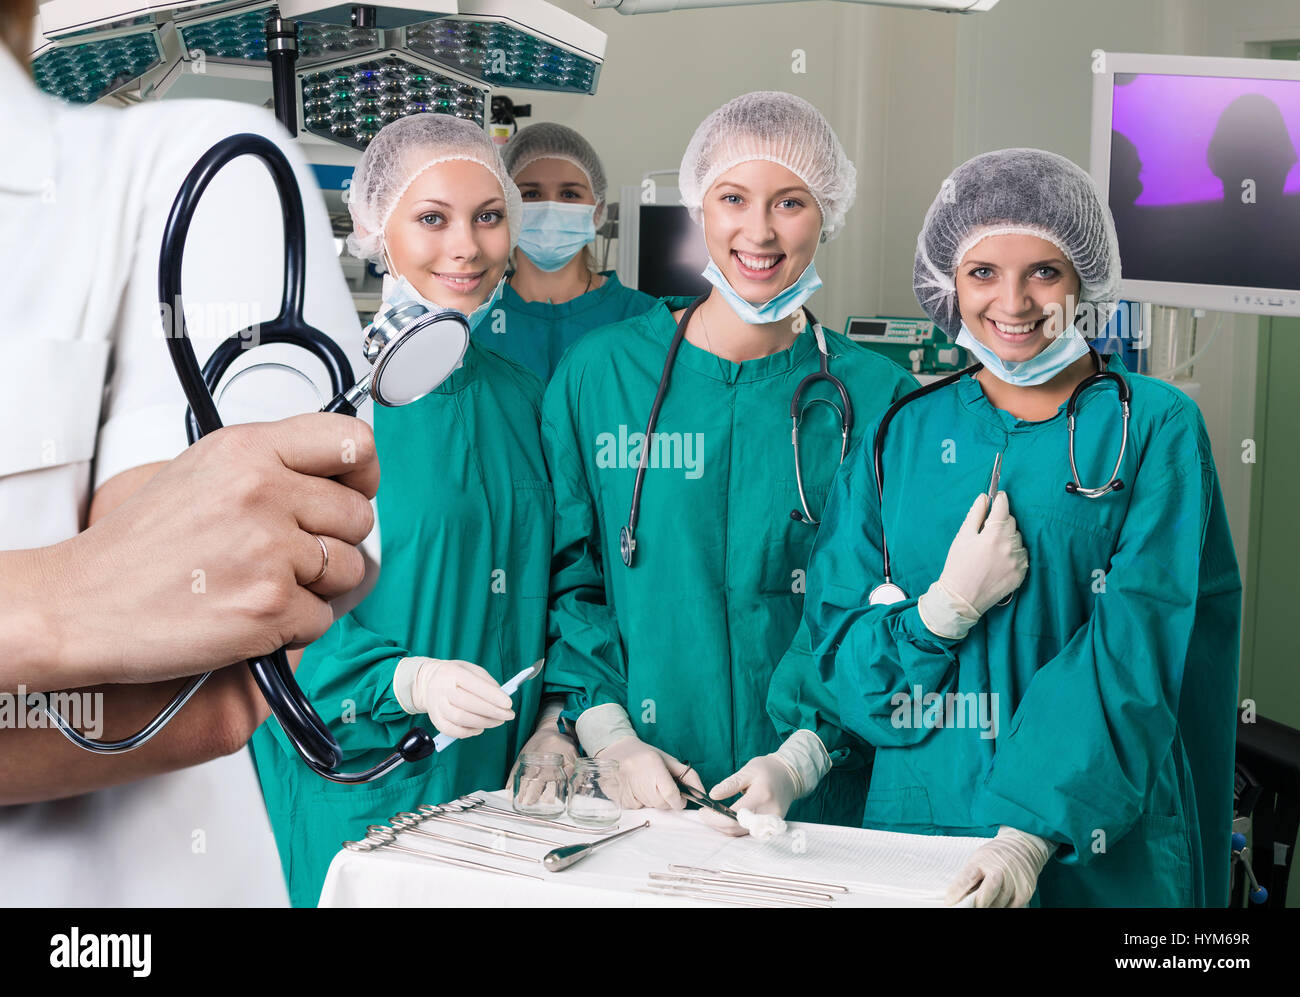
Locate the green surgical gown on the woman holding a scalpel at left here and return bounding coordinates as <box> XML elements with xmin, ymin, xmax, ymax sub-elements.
<box><xmin>252</xmin><ymin>341</ymin><xmax>554</xmax><ymax>906</ymax></box>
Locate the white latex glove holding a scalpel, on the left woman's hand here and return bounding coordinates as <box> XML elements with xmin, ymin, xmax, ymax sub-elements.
<box><xmin>393</xmin><ymin>658</ymin><xmax>515</xmax><ymax>737</ymax></box>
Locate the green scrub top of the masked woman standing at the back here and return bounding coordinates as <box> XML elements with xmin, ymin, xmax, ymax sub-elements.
<box><xmin>475</xmin><ymin>270</ymin><xmax>658</xmax><ymax>381</ymax></box>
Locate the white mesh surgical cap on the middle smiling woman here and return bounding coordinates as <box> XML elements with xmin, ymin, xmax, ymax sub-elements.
<box><xmin>677</xmin><ymin>90</ymin><xmax>858</xmax><ymax>239</ymax></box>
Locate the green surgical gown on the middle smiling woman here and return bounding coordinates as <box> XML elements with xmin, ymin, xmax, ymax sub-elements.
<box><xmin>542</xmin><ymin>298</ymin><xmax>917</xmax><ymax>824</ymax></box>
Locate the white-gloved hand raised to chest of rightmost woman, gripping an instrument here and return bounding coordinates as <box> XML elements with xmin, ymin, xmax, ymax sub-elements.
<box><xmin>917</xmin><ymin>491</ymin><xmax>1030</xmax><ymax>640</ymax></box>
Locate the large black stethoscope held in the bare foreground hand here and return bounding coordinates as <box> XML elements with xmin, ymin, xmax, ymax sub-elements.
<box><xmin>47</xmin><ymin>134</ymin><xmax>480</xmax><ymax>783</ymax></box>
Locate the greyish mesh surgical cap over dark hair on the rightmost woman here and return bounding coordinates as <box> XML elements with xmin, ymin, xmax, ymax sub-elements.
<box><xmin>911</xmin><ymin>149</ymin><xmax>1119</xmax><ymax>338</ymax></box>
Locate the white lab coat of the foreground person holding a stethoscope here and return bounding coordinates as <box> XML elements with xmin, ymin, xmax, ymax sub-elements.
<box><xmin>0</xmin><ymin>47</ymin><xmax>365</xmax><ymax>906</ymax></box>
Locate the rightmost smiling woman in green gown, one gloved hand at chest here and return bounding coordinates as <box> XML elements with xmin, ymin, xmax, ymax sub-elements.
<box><xmin>796</xmin><ymin>149</ymin><xmax>1242</xmax><ymax>906</ymax></box>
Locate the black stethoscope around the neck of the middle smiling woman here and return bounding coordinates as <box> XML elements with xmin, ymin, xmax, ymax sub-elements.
<box><xmin>619</xmin><ymin>294</ymin><xmax>853</xmax><ymax>568</ymax></box>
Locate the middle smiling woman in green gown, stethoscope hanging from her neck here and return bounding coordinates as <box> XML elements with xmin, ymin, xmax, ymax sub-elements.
<box><xmin>542</xmin><ymin>92</ymin><xmax>915</xmax><ymax>827</ymax></box>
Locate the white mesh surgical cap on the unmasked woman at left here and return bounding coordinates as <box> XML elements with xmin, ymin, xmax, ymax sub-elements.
<box><xmin>347</xmin><ymin>114</ymin><xmax>523</xmax><ymax>263</ymax></box>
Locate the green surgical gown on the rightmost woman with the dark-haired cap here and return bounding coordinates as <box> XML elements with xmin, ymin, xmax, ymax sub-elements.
<box><xmin>788</xmin><ymin>359</ymin><xmax>1242</xmax><ymax>906</ymax></box>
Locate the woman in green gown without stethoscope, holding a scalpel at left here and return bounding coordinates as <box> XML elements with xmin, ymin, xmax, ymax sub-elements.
<box><xmin>252</xmin><ymin>114</ymin><xmax>576</xmax><ymax>906</ymax></box>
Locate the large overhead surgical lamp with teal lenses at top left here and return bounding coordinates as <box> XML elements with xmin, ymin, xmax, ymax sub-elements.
<box><xmin>33</xmin><ymin>0</ymin><xmax>606</xmax><ymax>148</ymax></box>
